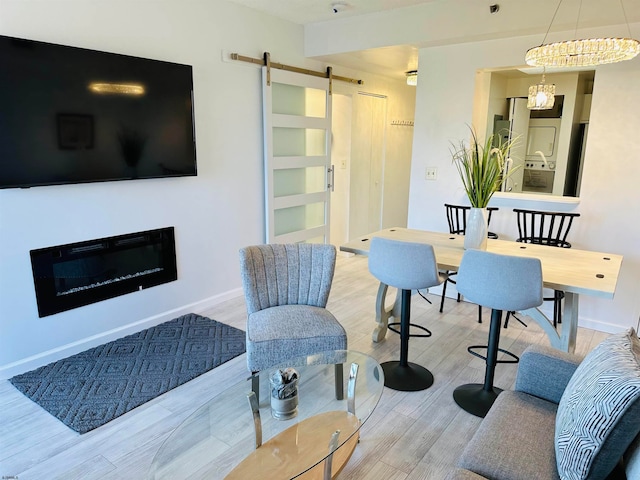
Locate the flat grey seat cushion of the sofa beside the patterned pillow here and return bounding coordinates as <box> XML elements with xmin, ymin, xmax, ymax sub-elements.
<box><xmin>458</xmin><ymin>391</ymin><xmax>560</xmax><ymax>480</ymax></box>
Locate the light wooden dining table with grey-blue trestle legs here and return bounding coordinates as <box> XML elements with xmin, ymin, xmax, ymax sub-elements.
<box><xmin>340</xmin><ymin>227</ymin><xmax>622</xmax><ymax>352</ymax></box>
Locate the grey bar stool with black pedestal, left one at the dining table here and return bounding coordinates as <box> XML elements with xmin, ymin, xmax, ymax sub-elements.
<box><xmin>369</xmin><ymin>237</ymin><xmax>446</xmax><ymax>392</ymax></box>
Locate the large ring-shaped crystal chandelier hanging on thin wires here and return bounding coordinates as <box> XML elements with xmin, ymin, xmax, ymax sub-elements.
<box><xmin>525</xmin><ymin>0</ymin><xmax>640</xmax><ymax>67</ymax></box>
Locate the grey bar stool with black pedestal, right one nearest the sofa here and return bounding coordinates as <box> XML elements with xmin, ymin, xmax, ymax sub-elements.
<box><xmin>453</xmin><ymin>250</ymin><xmax>542</xmax><ymax>417</ymax></box>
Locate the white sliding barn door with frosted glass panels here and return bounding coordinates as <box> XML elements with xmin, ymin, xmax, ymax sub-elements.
<box><xmin>262</xmin><ymin>67</ymin><xmax>333</xmax><ymax>243</ymax></box>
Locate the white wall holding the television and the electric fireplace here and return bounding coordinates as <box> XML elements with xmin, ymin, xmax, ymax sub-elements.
<box><xmin>0</xmin><ymin>0</ymin><xmax>416</xmax><ymax>378</ymax></box>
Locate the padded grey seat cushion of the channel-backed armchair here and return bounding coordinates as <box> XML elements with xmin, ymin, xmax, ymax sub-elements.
<box><xmin>247</xmin><ymin>305</ymin><xmax>347</xmax><ymax>372</ymax></box>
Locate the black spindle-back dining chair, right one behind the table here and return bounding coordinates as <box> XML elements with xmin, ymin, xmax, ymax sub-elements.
<box><xmin>504</xmin><ymin>208</ymin><xmax>580</xmax><ymax>328</ymax></box>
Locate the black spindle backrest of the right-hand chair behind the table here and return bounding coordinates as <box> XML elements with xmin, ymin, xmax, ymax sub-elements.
<box><xmin>513</xmin><ymin>208</ymin><xmax>580</xmax><ymax>248</ymax></box>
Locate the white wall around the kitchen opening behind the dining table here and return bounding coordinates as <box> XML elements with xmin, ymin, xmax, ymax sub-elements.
<box><xmin>409</xmin><ymin>32</ymin><xmax>640</xmax><ymax>331</ymax></box>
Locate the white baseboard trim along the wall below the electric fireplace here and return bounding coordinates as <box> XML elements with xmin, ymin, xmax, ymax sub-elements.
<box><xmin>0</xmin><ymin>288</ymin><xmax>242</xmax><ymax>380</ymax></box>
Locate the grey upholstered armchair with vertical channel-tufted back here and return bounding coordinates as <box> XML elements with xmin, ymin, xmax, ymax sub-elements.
<box><xmin>240</xmin><ymin>243</ymin><xmax>347</xmax><ymax>404</ymax></box>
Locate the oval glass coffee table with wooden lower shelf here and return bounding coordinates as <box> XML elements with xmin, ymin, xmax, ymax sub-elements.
<box><xmin>149</xmin><ymin>350</ymin><xmax>384</xmax><ymax>480</ymax></box>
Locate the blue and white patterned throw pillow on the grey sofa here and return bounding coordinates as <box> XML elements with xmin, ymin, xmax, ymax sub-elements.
<box><xmin>555</xmin><ymin>328</ymin><xmax>640</xmax><ymax>480</ymax></box>
